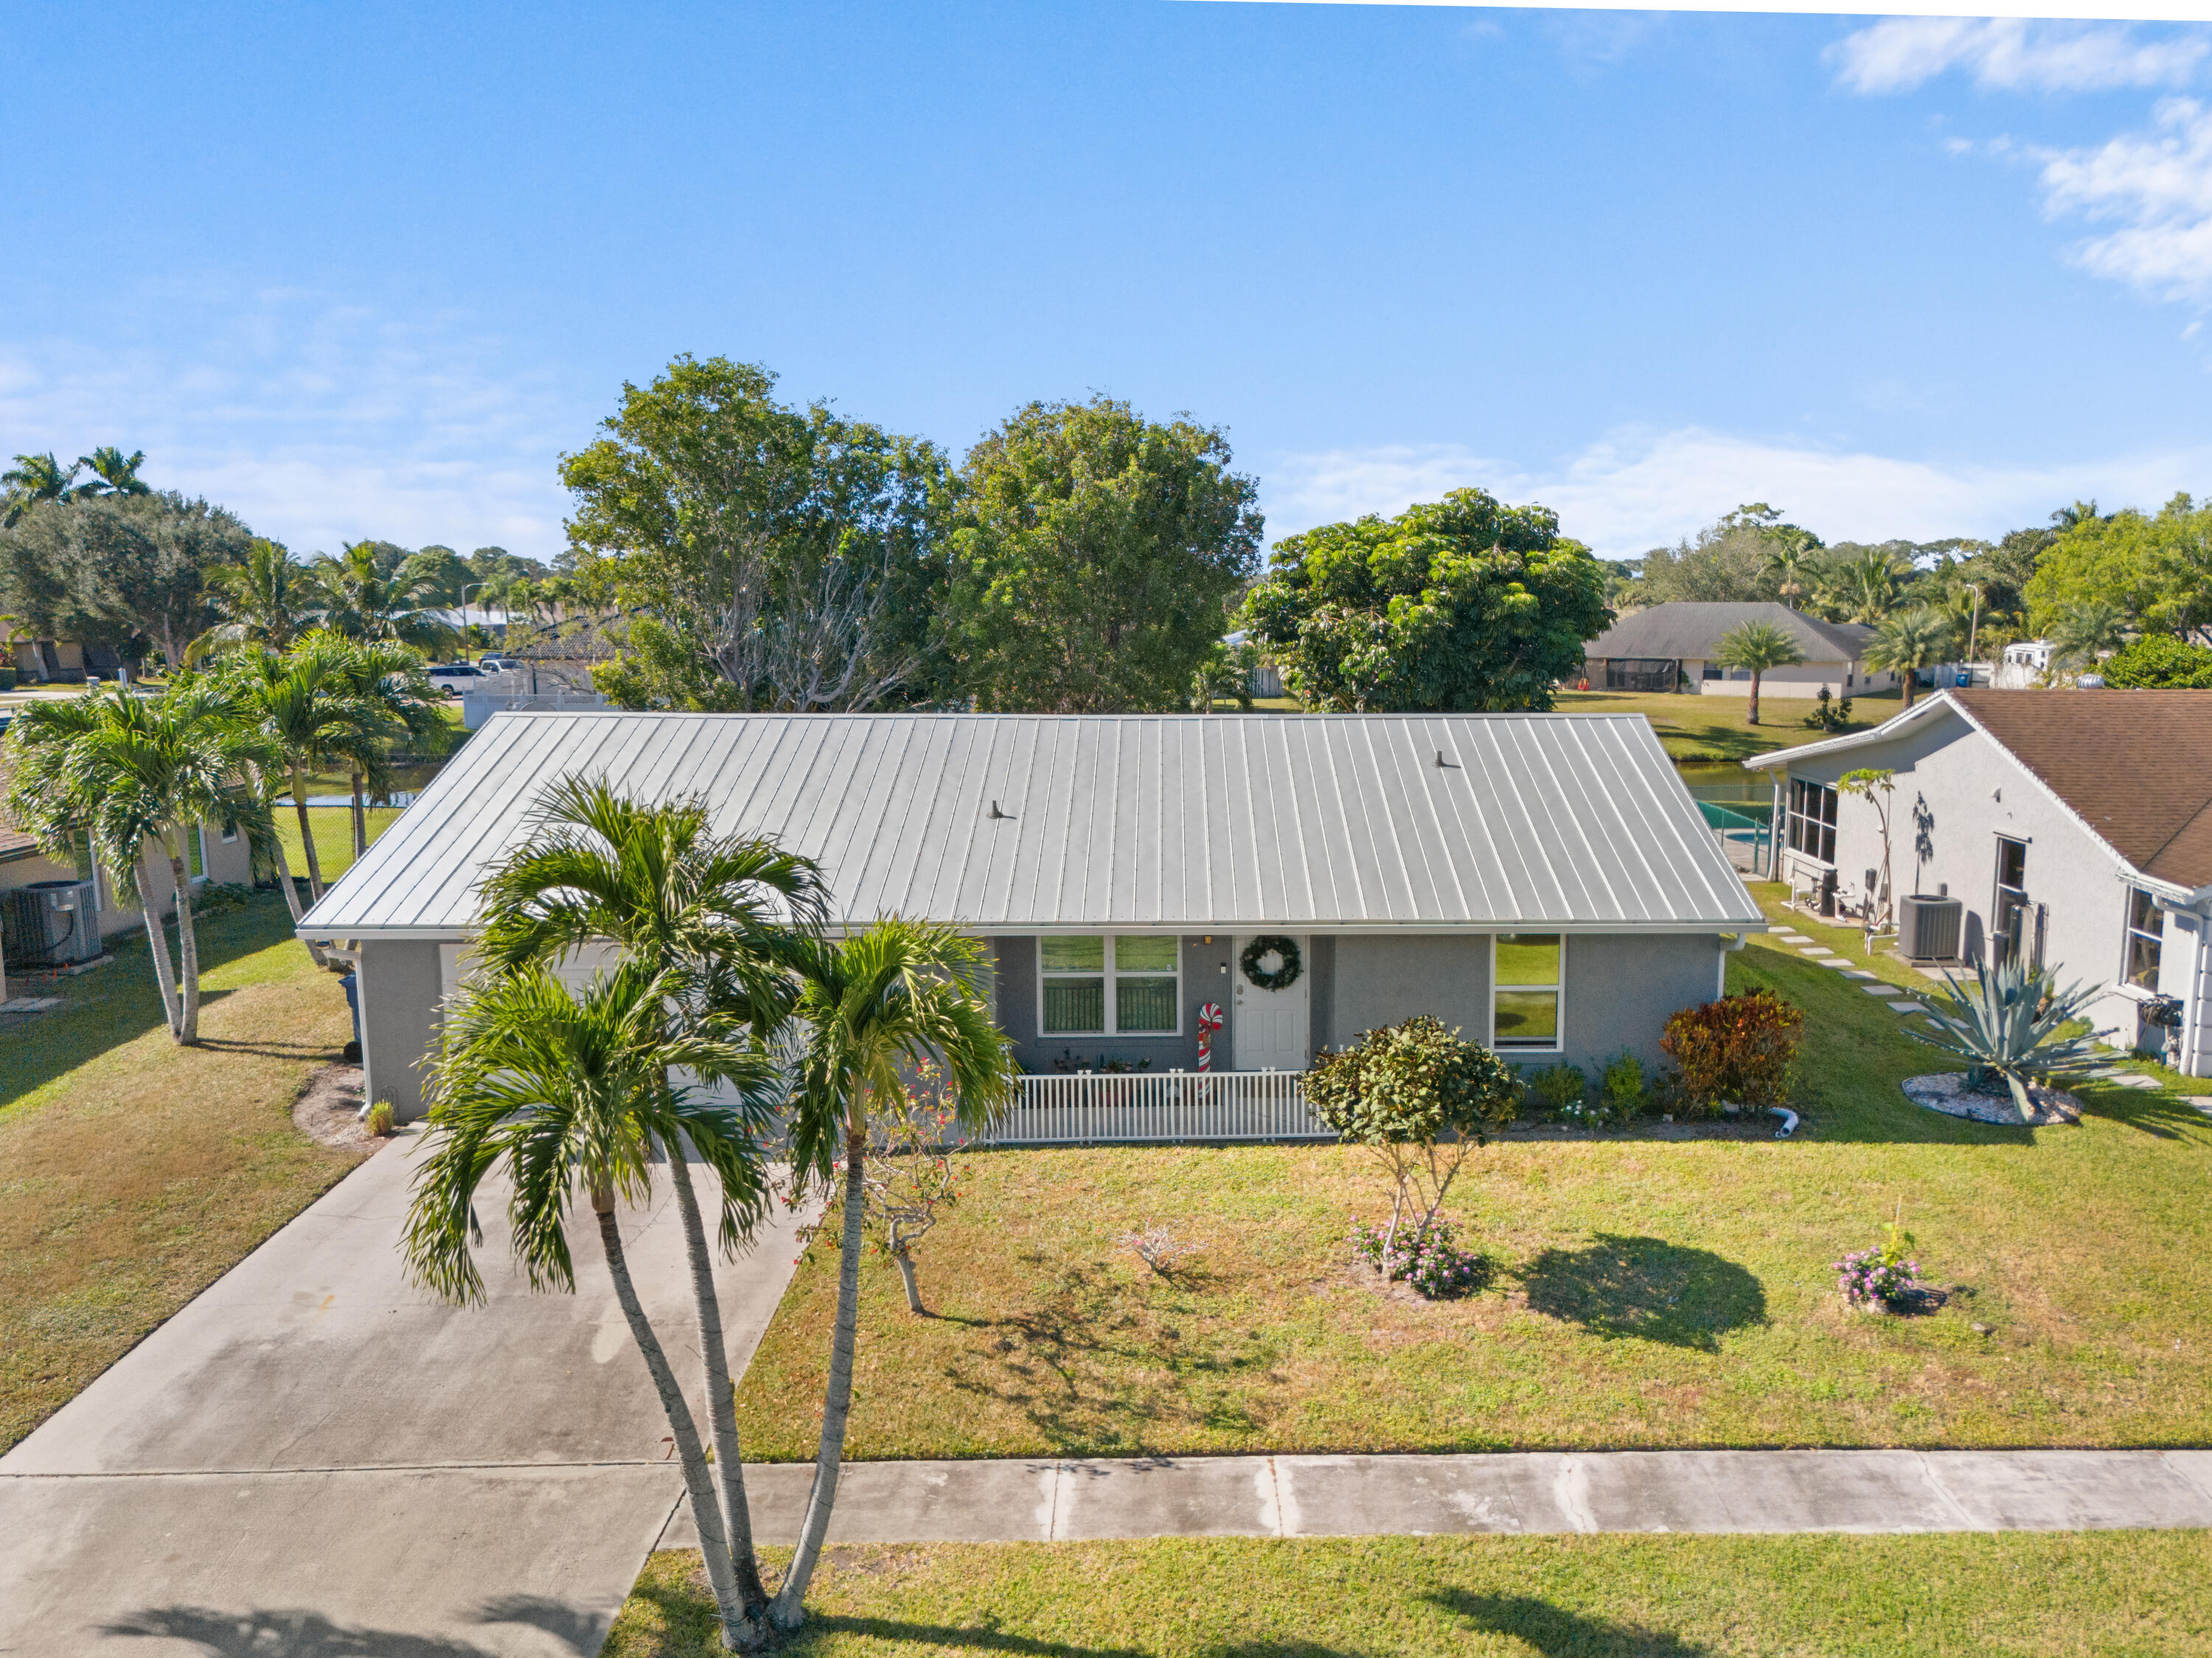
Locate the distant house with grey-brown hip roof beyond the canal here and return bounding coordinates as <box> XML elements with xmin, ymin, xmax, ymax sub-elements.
<box><xmin>1582</xmin><ymin>602</ymin><xmax>1898</xmax><ymax>697</ymax></box>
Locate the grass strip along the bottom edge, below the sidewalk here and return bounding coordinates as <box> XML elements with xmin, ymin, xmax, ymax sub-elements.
<box><xmin>604</xmin><ymin>1532</ymin><xmax>2212</xmax><ymax>1658</ymax></box>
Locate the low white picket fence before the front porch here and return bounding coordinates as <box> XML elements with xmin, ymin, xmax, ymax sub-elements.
<box><xmin>975</xmin><ymin>1070</ymin><xmax>1336</xmax><ymax>1145</ymax></box>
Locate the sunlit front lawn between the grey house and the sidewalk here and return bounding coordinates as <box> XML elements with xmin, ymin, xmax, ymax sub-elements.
<box><xmin>739</xmin><ymin>886</ymin><xmax>2212</xmax><ymax>1459</ymax></box>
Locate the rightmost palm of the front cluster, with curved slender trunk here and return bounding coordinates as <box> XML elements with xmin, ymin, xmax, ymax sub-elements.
<box><xmin>768</xmin><ymin>915</ymin><xmax>1013</xmax><ymax>1629</ymax></box>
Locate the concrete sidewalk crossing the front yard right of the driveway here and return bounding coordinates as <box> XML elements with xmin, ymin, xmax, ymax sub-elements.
<box><xmin>659</xmin><ymin>1450</ymin><xmax>2212</xmax><ymax>1547</ymax></box>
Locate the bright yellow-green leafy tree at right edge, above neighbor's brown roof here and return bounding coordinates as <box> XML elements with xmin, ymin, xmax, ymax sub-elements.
<box><xmin>2026</xmin><ymin>495</ymin><xmax>2212</xmax><ymax>646</ymax></box>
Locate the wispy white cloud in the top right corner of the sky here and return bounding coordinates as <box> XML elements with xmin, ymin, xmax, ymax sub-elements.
<box><xmin>1827</xmin><ymin>18</ymin><xmax>2212</xmax><ymax>93</ymax></box>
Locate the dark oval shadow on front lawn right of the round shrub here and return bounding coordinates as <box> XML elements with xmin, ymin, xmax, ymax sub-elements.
<box><xmin>1520</xmin><ymin>1231</ymin><xmax>1767</xmax><ymax>1353</ymax></box>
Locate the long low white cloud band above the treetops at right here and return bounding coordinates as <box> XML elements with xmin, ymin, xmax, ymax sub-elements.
<box><xmin>1263</xmin><ymin>427</ymin><xmax>2212</xmax><ymax>560</ymax></box>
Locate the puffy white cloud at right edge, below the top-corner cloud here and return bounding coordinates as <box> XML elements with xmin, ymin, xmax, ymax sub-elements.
<box><xmin>2039</xmin><ymin>97</ymin><xmax>2212</xmax><ymax>299</ymax></box>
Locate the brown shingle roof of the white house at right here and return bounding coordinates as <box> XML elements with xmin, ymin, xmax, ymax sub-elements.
<box><xmin>1951</xmin><ymin>690</ymin><xmax>2212</xmax><ymax>886</ymax></box>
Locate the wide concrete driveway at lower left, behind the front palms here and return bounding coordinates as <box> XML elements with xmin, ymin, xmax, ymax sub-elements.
<box><xmin>0</xmin><ymin>1138</ymin><xmax>814</xmax><ymax>1658</ymax></box>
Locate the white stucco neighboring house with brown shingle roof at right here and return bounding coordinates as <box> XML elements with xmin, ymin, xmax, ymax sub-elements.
<box><xmin>1745</xmin><ymin>690</ymin><xmax>2212</xmax><ymax>1076</ymax></box>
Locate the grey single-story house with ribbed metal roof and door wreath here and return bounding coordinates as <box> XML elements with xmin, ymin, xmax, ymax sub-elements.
<box><xmin>301</xmin><ymin>712</ymin><xmax>1765</xmax><ymax>1118</ymax></box>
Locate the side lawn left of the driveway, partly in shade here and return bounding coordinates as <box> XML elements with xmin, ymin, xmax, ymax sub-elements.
<box><xmin>0</xmin><ymin>893</ymin><xmax>372</xmax><ymax>1450</ymax></box>
